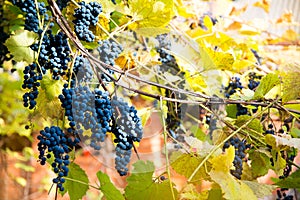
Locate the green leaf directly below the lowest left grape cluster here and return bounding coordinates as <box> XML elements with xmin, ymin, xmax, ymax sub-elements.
<box><xmin>64</xmin><ymin>163</ymin><xmax>89</xmax><ymax>200</ymax></box>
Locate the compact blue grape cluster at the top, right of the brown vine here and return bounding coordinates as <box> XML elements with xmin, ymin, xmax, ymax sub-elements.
<box><xmin>73</xmin><ymin>1</ymin><xmax>102</xmax><ymax>42</ymax></box>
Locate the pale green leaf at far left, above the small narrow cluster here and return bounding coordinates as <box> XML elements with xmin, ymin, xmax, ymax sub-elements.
<box><xmin>5</xmin><ymin>30</ymin><xmax>38</xmax><ymax>63</ymax></box>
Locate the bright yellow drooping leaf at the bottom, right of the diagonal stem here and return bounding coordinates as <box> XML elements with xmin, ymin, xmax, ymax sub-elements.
<box><xmin>209</xmin><ymin>146</ymin><xmax>257</xmax><ymax>200</ymax></box>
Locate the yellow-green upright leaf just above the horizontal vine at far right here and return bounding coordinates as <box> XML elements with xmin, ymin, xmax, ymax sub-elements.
<box><xmin>254</xmin><ymin>73</ymin><xmax>280</xmax><ymax>99</ymax></box>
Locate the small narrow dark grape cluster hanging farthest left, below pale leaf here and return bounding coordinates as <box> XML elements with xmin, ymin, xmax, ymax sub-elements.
<box><xmin>22</xmin><ymin>63</ymin><xmax>42</xmax><ymax>109</ymax></box>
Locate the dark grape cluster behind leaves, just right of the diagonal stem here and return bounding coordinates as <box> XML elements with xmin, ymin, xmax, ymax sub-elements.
<box><xmin>223</xmin><ymin>137</ymin><xmax>249</xmax><ymax>179</ymax></box>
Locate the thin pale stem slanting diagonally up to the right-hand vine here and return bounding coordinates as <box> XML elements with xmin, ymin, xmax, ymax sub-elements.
<box><xmin>188</xmin><ymin>103</ymin><xmax>274</xmax><ymax>182</ymax></box>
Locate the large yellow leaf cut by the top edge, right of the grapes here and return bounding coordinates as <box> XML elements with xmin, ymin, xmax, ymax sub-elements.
<box><xmin>128</xmin><ymin>0</ymin><xmax>174</xmax><ymax>30</ymax></box>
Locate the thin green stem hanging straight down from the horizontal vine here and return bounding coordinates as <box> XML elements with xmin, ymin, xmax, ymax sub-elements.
<box><xmin>160</xmin><ymin>99</ymin><xmax>175</xmax><ymax>200</ymax></box>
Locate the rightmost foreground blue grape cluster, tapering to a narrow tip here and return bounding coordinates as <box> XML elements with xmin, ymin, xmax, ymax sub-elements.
<box><xmin>111</xmin><ymin>96</ymin><xmax>143</xmax><ymax>176</ymax></box>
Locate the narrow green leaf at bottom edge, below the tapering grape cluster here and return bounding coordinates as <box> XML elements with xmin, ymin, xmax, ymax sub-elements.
<box><xmin>97</xmin><ymin>171</ymin><xmax>125</xmax><ymax>200</ymax></box>
